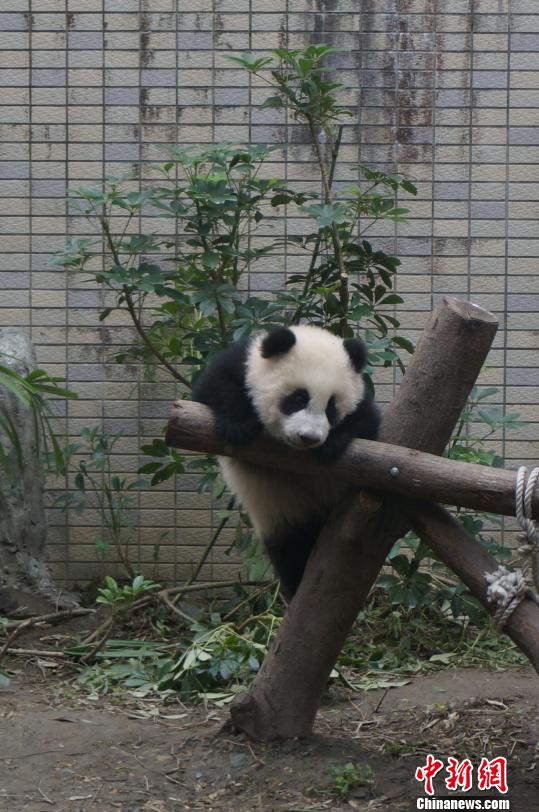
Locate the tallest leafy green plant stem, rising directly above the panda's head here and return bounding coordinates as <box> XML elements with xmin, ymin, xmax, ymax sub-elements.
<box><xmin>231</xmin><ymin>44</ymin><xmax>417</xmax><ymax>346</ymax></box>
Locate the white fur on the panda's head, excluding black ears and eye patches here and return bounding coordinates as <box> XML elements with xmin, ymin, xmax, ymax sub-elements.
<box><xmin>246</xmin><ymin>325</ymin><xmax>365</xmax><ymax>449</ymax></box>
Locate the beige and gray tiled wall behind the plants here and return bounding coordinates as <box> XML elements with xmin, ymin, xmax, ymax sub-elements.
<box><xmin>0</xmin><ymin>0</ymin><xmax>539</xmax><ymax>583</ymax></box>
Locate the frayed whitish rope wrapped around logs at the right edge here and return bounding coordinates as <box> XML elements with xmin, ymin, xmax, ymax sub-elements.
<box><xmin>485</xmin><ymin>466</ymin><xmax>539</xmax><ymax>630</ymax></box>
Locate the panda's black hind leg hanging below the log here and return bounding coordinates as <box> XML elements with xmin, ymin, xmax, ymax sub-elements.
<box><xmin>264</xmin><ymin>521</ymin><xmax>322</xmax><ymax>600</ymax></box>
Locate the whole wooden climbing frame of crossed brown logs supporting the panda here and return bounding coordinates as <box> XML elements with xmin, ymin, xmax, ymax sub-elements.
<box><xmin>166</xmin><ymin>298</ymin><xmax>539</xmax><ymax>740</ymax></box>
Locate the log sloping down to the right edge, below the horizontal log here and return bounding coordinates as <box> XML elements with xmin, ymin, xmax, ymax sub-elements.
<box><xmin>408</xmin><ymin>499</ymin><xmax>539</xmax><ymax>673</ymax></box>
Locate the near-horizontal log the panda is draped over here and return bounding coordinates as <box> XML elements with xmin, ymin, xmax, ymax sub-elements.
<box><xmin>166</xmin><ymin>400</ymin><xmax>539</xmax><ymax>519</ymax></box>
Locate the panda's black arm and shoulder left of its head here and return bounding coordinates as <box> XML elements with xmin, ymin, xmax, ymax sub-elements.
<box><xmin>192</xmin><ymin>341</ymin><xmax>262</xmax><ymax>445</ymax></box>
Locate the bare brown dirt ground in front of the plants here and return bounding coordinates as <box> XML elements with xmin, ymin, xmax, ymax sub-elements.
<box><xmin>0</xmin><ymin>661</ymin><xmax>539</xmax><ymax>812</ymax></box>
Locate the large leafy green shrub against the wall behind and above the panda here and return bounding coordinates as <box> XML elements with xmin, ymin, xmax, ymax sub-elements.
<box><xmin>54</xmin><ymin>45</ymin><xmax>416</xmax><ymax>502</ymax></box>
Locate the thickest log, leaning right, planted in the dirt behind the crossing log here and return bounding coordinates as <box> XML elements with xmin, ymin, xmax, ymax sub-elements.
<box><xmin>227</xmin><ymin>298</ymin><xmax>497</xmax><ymax>740</ymax></box>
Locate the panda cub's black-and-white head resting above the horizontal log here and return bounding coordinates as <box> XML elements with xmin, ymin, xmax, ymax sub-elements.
<box><xmin>246</xmin><ymin>325</ymin><xmax>367</xmax><ymax>450</ymax></box>
